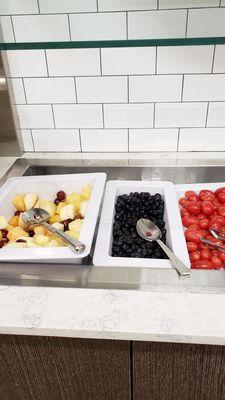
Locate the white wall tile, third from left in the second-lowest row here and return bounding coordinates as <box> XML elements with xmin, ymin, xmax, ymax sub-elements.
<box><xmin>104</xmin><ymin>104</ymin><xmax>154</xmax><ymax>128</ymax></box>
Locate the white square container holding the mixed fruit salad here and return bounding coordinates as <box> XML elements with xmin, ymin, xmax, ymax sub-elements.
<box><xmin>0</xmin><ymin>173</ymin><xmax>106</xmax><ymax>264</ymax></box>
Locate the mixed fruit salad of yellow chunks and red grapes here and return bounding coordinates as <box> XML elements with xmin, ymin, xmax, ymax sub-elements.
<box><xmin>0</xmin><ymin>184</ymin><xmax>92</xmax><ymax>248</ymax></box>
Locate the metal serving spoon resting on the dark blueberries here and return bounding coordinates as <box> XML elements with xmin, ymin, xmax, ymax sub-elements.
<box><xmin>136</xmin><ymin>218</ymin><xmax>191</xmax><ymax>276</ymax></box>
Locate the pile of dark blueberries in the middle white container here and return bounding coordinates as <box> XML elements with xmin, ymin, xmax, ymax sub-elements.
<box><xmin>112</xmin><ymin>192</ymin><xmax>167</xmax><ymax>259</ymax></box>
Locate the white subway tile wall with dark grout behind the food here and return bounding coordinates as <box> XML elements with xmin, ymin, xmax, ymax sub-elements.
<box><xmin>0</xmin><ymin>0</ymin><xmax>225</xmax><ymax>153</ymax></box>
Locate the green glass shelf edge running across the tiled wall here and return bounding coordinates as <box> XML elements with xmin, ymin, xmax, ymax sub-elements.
<box><xmin>0</xmin><ymin>36</ymin><xmax>225</xmax><ymax>50</ymax></box>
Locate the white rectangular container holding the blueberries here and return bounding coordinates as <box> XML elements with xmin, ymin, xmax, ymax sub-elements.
<box><xmin>93</xmin><ymin>181</ymin><xmax>190</xmax><ymax>268</ymax></box>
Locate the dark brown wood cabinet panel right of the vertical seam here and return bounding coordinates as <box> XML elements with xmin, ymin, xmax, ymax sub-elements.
<box><xmin>133</xmin><ymin>342</ymin><xmax>225</xmax><ymax>400</ymax></box>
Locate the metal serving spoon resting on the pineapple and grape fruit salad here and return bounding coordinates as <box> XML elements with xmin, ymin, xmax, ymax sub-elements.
<box><xmin>22</xmin><ymin>208</ymin><xmax>85</xmax><ymax>254</ymax></box>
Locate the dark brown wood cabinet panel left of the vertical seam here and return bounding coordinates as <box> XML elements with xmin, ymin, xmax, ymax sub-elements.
<box><xmin>0</xmin><ymin>335</ymin><xmax>130</xmax><ymax>400</ymax></box>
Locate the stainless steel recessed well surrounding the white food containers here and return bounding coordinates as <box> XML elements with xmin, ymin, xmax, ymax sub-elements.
<box><xmin>0</xmin><ymin>159</ymin><xmax>225</xmax><ymax>293</ymax></box>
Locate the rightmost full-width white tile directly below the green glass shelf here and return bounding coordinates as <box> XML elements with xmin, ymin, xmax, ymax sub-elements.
<box><xmin>157</xmin><ymin>46</ymin><xmax>213</xmax><ymax>74</ymax></box>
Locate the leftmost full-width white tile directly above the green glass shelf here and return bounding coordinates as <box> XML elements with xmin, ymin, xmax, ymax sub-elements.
<box><xmin>13</xmin><ymin>15</ymin><xmax>70</xmax><ymax>42</ymax></box>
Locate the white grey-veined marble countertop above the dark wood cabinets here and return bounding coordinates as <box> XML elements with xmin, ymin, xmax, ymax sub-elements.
<box><xmin>0</xmin><ymin>158</ymin><xmax>225</xmax><ymax>345</ymax></box>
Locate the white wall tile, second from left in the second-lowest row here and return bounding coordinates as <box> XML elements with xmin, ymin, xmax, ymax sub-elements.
<box><xmin>53</xmin><ymin>104</ymin><xmax>103</xmax><ymax>128</ymax></box>
